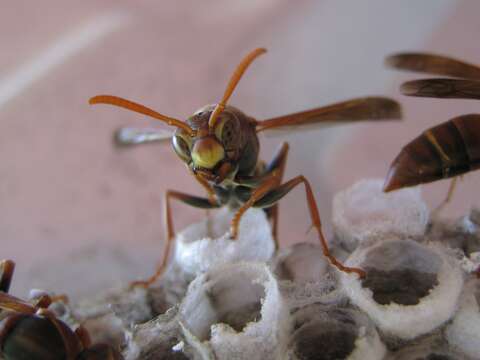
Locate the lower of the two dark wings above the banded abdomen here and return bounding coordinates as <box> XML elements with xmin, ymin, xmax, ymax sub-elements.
<box><xmin>400</xmin><ymin>78</ymin><xmax>480</xmax><ymax>99</ymax></box>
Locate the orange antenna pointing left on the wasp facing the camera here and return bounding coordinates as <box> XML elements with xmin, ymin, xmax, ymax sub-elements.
<box><xmin>88</xmin><ymin>95</ymin><xmax>194</xmax><ymax>135</ymax></box>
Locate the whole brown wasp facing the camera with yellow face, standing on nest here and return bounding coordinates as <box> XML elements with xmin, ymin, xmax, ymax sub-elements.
<box><xmin>90</xmin><ymin>48</ymin><xmax>400</xmax><ymax>285</ymax></box>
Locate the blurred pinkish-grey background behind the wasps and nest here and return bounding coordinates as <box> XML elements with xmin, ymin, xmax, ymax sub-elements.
<box><xmin>0</xmin><ymin>0</ymin><xmax>480</xmax><ymax>298</ymax></box>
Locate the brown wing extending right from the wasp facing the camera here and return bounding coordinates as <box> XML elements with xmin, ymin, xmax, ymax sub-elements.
<box><xmin>257</xmin><ymin>97</ymin><xmax>402</xmax><ymax>131</ymax></box>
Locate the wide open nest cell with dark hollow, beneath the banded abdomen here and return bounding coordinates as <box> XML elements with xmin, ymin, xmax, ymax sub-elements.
<box><xmin>341</xmin><ymin>240</ymin><xmax>463</xmax><ymax>339</ymax></box>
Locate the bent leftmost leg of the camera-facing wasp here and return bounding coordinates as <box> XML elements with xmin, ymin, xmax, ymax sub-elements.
<box><xmin>130</xmin><ymin>190</ymin><xmax>220</xmax><ymax>287</ymax></box>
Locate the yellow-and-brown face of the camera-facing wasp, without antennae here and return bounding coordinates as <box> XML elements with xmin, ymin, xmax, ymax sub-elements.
<box><xmin>172</xmin><ymin>106</ymin><xmax>243</xmax><ymax>184</ymax></box>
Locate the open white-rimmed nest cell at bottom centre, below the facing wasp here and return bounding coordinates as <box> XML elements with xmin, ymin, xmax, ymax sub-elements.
<box><xmin>179</xmin><ymin>263</ymin><xmax>290</xmax><ymax>360</ymax></box>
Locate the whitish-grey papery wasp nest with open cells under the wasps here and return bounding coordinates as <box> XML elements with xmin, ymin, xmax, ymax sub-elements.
<box><xmin>43</xmin><ymin>180</ymin><xmax>480</xmax><ymax>360</ymax></box>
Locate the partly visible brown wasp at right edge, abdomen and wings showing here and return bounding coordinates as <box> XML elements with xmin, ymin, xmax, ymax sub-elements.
<box><xmin>384</xmin><ymin>53</ymin><xmax>480</xmax><ymax>205</ymax></box>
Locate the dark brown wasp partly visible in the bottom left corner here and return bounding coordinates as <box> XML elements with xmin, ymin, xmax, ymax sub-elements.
<box><xmin>0</xmin><ymin>260</ymin><xmax>123</xmax><ymax>360</ymax></box>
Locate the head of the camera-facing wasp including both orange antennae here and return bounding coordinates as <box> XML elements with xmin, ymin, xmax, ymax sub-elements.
<box><xmin>89</xmin><ymin>48</ymin><xmax>266</xmax><ymax>184</ymax></box>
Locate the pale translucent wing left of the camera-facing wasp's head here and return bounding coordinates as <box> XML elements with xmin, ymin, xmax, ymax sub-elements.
<box><xmin>113</xmin><ymin>127</ymin><xmax>173</xmax><ymax>147</ymax></box>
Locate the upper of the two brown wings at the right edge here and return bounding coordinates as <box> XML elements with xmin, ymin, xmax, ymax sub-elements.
<box><xmin>385</xmin><ymin>53</ymin><xmax>480</xmax><ymax>80</ymax></box>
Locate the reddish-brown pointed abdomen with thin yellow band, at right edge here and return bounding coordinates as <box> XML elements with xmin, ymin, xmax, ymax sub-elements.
<box><xmin>384</xmin><ymin>114</ymin><xmax>480</xmax><ymax>191</ymax></box>
